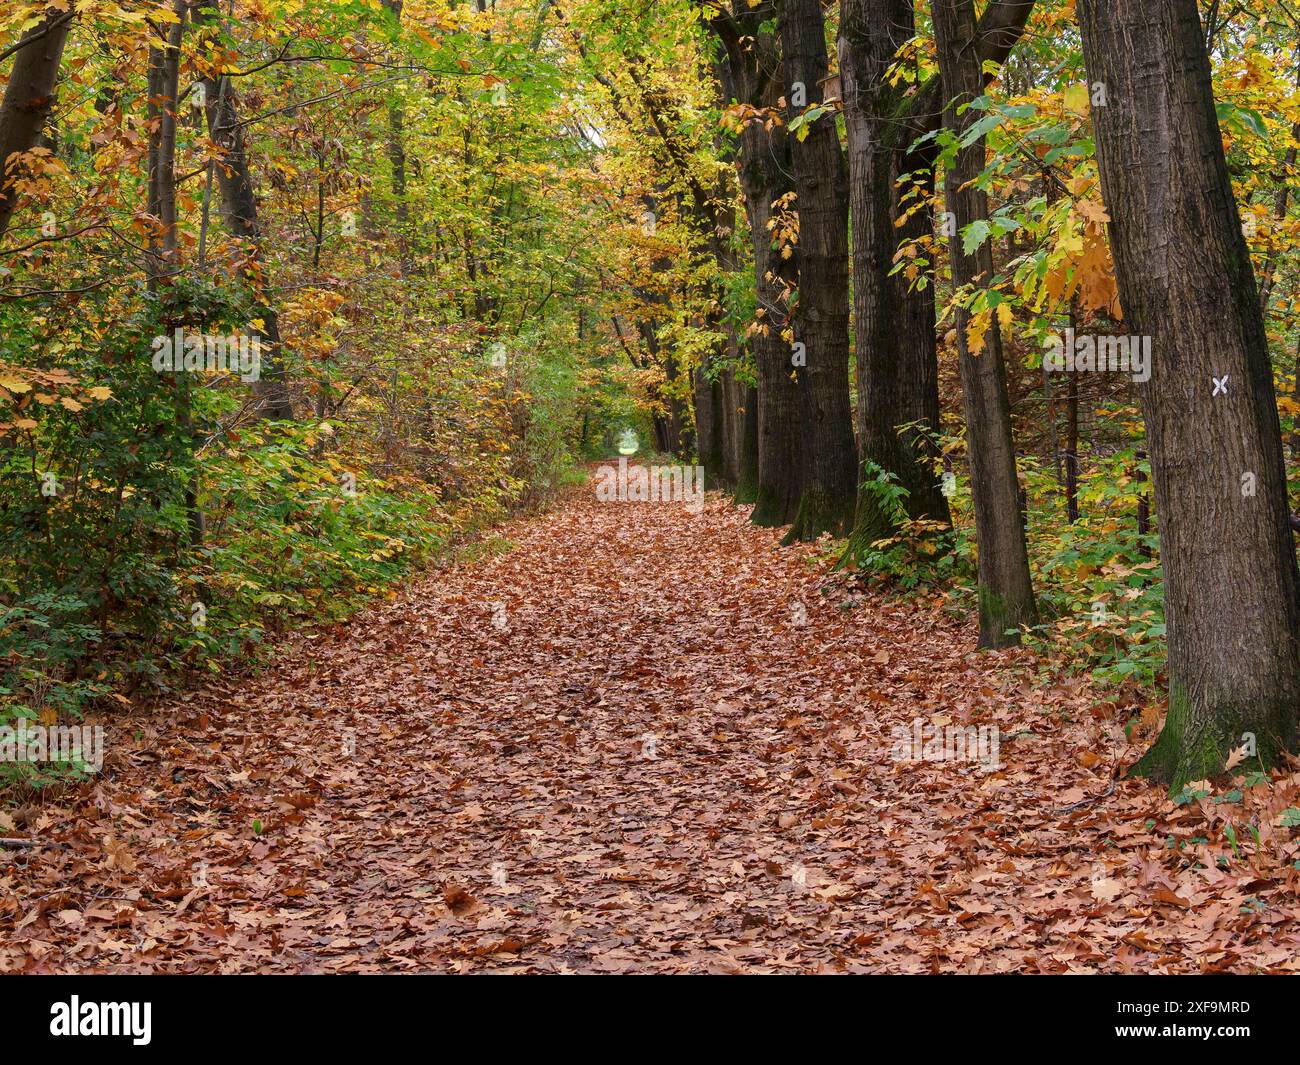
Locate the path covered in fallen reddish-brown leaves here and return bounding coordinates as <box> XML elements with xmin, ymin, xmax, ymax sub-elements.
<box><xmin>0</xmin><ymin>494</ymin><xmax>1300</xmax><ymax>973</ymax></box>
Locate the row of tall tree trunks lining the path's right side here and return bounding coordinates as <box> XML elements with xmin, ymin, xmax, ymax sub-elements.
<box><xmin>655</xmin><ymin>0</ymin><xmax>1300</xmax><ymax>784</ymax></box>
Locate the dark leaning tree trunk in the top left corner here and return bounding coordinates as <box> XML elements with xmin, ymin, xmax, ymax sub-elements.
<box><xmin>0</xmin><ymin>8</ymin><xmax>74</xmax><ymax>238</ymax></box>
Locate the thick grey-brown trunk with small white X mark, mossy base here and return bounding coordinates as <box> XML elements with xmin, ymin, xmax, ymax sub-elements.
<box><xmin>1079</xmin><ymin>0</ymin><xmax>1300</xmax><ymax>788</ymax></box>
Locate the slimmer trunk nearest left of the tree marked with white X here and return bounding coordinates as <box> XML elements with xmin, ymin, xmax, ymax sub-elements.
<box><xmin>933</xmin><ymin>0</ymin><xmax>1037</xmax><ymax>648</ymax></box>
